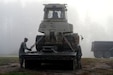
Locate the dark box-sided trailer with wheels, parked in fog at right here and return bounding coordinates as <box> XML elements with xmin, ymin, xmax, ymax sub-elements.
<box><xmin>91</xmin><ymin>41</ymin><xmax>113</xmax><ymax>58</ymax></box>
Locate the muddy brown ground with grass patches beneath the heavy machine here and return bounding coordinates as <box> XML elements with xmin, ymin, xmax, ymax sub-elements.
<box><xmin>0</xmin><ymin>58</ymin><xmax>113</xmax><ymax>75</ymax></box>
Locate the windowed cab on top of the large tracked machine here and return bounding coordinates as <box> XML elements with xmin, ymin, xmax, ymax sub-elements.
<box><xmin>44</xmin><ymin>4</ymin><xmax>67</xmax><ymax>21</ymax></box>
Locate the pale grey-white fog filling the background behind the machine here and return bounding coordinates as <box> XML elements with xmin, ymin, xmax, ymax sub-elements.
<box><xmin>0</xmin><ymin>0</ymin><xmax>113</xmax><ymax>57</ymax></box>
